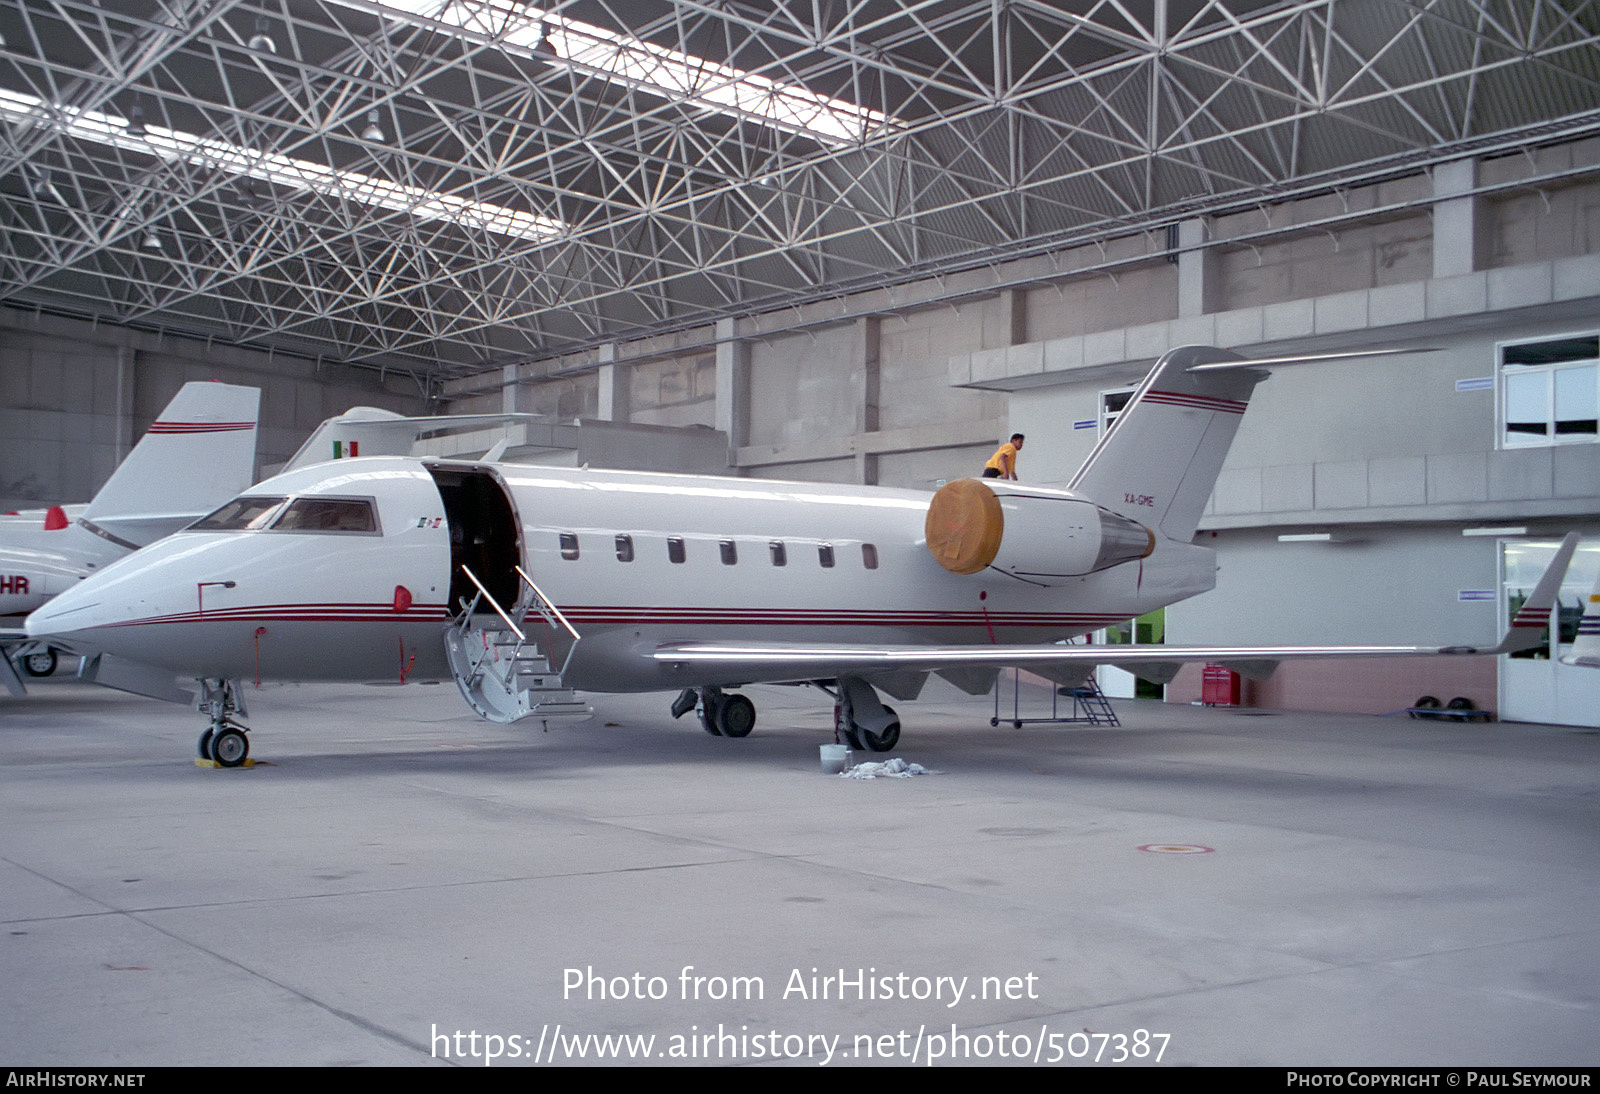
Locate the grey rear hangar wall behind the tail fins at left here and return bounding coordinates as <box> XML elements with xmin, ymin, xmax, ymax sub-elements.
<box><xmin>0</xmin><ymin>309</ymin><xmax>426</xmax><ymax>509</ymax></box>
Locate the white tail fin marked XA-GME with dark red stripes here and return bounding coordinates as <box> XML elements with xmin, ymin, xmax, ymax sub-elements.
<box><xmin>1069</xmin><ymin>345</ymin><xmax>1267</xmax><ymax>542</ymax></box>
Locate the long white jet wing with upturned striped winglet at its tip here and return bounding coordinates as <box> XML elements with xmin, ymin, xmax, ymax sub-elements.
<box><xmin>651</xmin><ymin>533</ymin><xmax>1578</xmax><ymax>683</ymax></box>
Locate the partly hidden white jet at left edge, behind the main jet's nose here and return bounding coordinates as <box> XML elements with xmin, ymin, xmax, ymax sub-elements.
<box><xmin>0</xmin><ymin>382</ymin><xmax>261</xmax><ymax>696</ymax></box>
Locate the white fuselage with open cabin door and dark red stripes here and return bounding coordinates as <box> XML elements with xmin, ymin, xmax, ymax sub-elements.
<box><xmin>29</xmin><ymin>457</ymin><xmax>1214</xmax><ymax>691</ymax></box>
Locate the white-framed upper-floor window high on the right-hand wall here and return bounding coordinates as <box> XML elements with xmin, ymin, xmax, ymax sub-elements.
<box><xmin>1498</xmin><ymin>334</ymin><xmax>1600</xmax><ymax>448</ymax></box>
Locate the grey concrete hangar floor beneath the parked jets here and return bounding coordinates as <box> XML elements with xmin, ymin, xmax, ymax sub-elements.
<box><xmin>0</xmin><ymin>680</ymin><xmax>1600</xmax><ymax>1067</ymax></box>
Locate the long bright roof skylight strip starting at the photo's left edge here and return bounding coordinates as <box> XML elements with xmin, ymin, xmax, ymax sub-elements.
<box><xmin>0</xmin><ymin>88</ymin><xmax>566</xmax><ymax>240</ymax></box>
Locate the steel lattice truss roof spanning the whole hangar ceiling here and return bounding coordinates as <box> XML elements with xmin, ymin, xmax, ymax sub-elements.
<box><xmin>0</xmin><ymin>0</ymin><xmax>1600</xmax><ymax>384</ymax></box>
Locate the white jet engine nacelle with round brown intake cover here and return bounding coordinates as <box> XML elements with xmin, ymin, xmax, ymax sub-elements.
<box><xmin>923</xmin><ymin>478</ymin><xmax>1155</xmax><ymax>585</ymax></box>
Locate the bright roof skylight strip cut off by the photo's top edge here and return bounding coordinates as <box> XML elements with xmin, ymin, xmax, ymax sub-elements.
<box><xmin>379</xmin><ymin>0</ymin><xmax>890</xmax><ymax>144</ymax></box>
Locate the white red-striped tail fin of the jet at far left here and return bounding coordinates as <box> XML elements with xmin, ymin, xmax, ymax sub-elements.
<box><xmin>78</xmin><ymin>382</ymin><xmax>261</xmax><ymax>547</ymax></box>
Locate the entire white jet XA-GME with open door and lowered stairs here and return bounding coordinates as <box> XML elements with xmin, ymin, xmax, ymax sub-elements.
<box><xmin>27</xmin><ymin>347</ymin><xmax>1576</xmax><ymax>766</ymax></box>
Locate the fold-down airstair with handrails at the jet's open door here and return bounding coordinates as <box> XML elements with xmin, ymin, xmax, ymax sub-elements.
<box><xmin>445</xmin><ymin>566</ymin><xmax>594</xmax><ymax>728</ymax></box>
